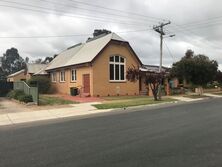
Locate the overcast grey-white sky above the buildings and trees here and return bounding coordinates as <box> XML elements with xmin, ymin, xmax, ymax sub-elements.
<box><xmin>0</xmin><ymin>0</ymin><xmax>222</xmax><ymax>69</ymax></box>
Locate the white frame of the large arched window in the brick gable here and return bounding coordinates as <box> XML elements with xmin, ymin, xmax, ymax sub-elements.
<box><xmin>109</xmin><ymin>55</ymin><xmax>126</xmax><ymax>82</ymax></box>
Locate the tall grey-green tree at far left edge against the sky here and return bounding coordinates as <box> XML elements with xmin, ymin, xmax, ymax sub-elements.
<box><xmin>1</xmin><ymin>48</ymin><xmax>25</xmax><ymax>78</ymax></box>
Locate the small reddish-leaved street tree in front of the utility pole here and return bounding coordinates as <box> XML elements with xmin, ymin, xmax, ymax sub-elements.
<box><xmin>126</xmin><ymin>67</ymin><xmax>166</xmax><ymax>100</ymax></box>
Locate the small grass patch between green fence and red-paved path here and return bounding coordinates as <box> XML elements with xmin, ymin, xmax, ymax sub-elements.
<box><xmin>39</xmin><ymin>95</ymin><xmax>78</xmax><ymax>106</ymax></box>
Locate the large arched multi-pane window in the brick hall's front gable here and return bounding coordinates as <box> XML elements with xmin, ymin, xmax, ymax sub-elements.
<box><xmin>109</xmin><ymin>55</ymin><xmax>126</xmax><ymax>81</ymax></box>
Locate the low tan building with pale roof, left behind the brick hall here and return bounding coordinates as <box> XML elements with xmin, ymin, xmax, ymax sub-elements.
<box><xmin>7</xmin><ymin>63</ymin><xmax>48</xmax><ymax>82</ymax></box>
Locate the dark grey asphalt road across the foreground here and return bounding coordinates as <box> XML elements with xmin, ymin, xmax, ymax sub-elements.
<box><xmin>0</xmin><ymin>99</ymin><xmax>222</xmax><ymax>167</ymax></box>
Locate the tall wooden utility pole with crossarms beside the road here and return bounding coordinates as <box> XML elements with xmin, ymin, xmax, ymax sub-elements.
<box><xmin>153</xmin><ymin>21</ymin><xmax>171</xmax><ymax>99</ymax></box>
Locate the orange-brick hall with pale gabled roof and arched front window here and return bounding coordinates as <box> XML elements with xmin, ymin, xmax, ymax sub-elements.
<box><xmin>46</xmin><ymin>33</ymin><xmax>142</xmax><ymax>96</ymax></box>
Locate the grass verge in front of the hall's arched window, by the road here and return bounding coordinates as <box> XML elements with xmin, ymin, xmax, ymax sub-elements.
<box><xmin>93</xmin><ymin>96</ymin><xmax>176</xmax><ymax>109</ymax></box>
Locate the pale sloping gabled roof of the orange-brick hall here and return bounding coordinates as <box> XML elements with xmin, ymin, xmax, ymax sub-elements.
<box><xmin>46</xmin><ymin>33</ymin><xmax>126</xmax><ymax>70</ymax></box>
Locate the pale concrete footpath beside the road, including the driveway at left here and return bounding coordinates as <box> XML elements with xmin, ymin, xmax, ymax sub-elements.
<box><xmin>0</xmin><ymin>94</ymin><xmax>222</xmax><ymax>126</ymax></box>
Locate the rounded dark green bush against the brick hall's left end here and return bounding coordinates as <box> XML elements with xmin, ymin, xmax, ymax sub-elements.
<box><xmin>28</xmin><ymin>76</ymin><xmax>51</xmax><ymax>93</ymax></box>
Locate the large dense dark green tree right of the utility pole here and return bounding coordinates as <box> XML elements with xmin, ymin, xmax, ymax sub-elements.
<box><xmin>171</xmin><ymin>50</ymin><xmax>218</xmax><ymax>94</ymax></box>
